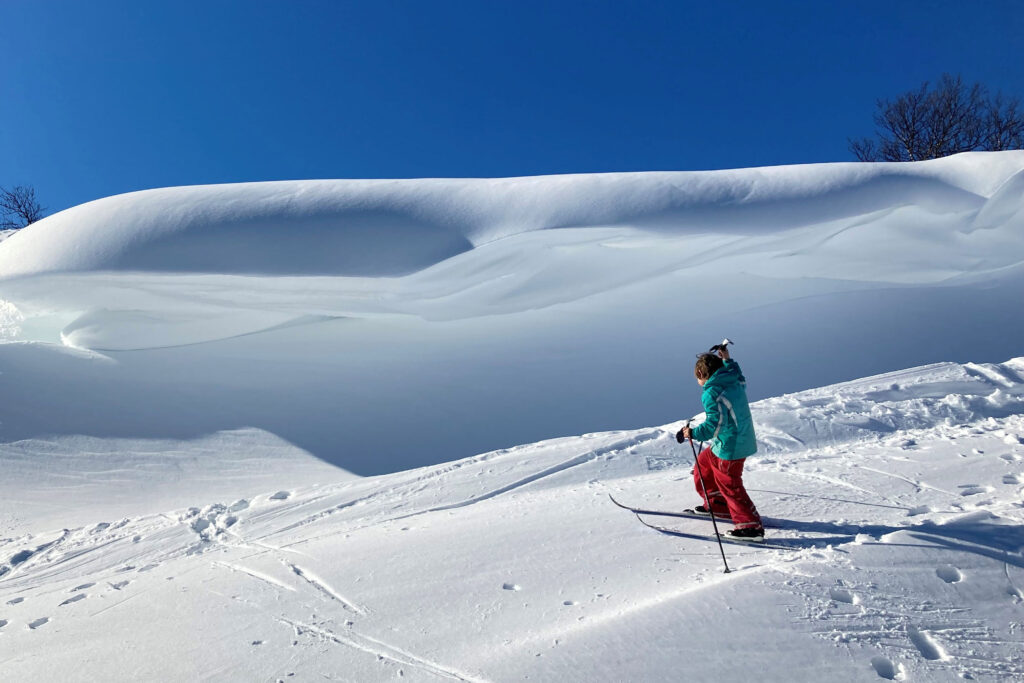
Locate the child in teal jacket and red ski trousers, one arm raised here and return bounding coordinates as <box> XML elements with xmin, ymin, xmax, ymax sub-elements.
<box><xmin>676</xmin><ymin>344</ymin><xmax>765</xmax><ymax>541</ymax></box>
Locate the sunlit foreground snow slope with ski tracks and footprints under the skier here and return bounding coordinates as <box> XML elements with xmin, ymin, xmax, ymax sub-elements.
<box><xmin>0</xmin><ymin>357</ymin><xmax>1024</xmax><ymax>681</ymax></box>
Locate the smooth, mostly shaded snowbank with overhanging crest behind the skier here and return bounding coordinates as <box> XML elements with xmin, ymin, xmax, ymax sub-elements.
<box><xmin>0</xmin><ymin>152</ymin><xmax>1024</xmax><ymax>475</ymax></box>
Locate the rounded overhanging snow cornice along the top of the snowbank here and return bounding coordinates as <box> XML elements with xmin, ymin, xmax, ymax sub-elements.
<box><xmin>0</xmin><ymin>152</ymin><xmax>1024</xmax><ymax>278</ymax></box>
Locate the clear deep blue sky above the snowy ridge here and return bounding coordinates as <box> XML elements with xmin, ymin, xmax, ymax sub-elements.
<box><xmin>0</xmin><ymin>0</ymin><xmax>1024</xmax><ymax>210</ymax></box>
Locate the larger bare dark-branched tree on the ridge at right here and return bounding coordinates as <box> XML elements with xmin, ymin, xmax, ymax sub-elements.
<box><xmin>849</xmin><ymin>74</ymin><xmax>1024</xmax><ymax>161</ymax></box>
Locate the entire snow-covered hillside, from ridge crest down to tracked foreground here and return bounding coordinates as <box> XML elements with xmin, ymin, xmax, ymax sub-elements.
<box><xmin>0</xmin><ymin>156</ymin><xmax>1024</xmax><ymax>682</ymax></box>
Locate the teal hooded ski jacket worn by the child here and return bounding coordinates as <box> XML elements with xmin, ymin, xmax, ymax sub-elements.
<box><xmin>692</xmin><ymin>359</ymin><xmax>758</xmax><ymax>460</ymax></box>
